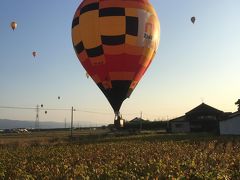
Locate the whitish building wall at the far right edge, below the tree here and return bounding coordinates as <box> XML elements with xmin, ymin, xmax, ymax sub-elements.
<box><xmin>219</xmin><ymin>116</ymin><xmax>240</xmax><ymax>135</ymax></box>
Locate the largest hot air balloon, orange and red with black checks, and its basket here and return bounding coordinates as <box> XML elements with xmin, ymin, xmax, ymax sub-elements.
<box><xmin>72</xmin><ymin>0</ymin><xmax>160</xmax><ymax>126</ymax></box>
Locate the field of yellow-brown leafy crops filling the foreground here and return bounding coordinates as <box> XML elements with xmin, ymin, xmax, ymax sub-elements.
<box><xmin>0</xmin><ymin>134</ymin><xmax>240</xmax><ymax>179</ymax></box>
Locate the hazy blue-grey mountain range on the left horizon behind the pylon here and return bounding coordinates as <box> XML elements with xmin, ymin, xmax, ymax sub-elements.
<box><xmin>0</xmin><ymin>119</ymin><xmax>65</xmax><ymax>129</ymax></box>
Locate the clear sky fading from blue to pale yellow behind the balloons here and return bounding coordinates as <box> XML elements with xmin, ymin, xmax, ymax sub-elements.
<box><xmin>0</xmin><ymin>0</ymin><xmax>240</xmax><ymax>125</ymax></box>
